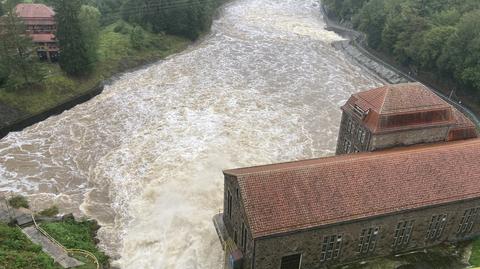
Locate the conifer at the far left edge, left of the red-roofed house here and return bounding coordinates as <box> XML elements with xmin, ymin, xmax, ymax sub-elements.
<box><xmin>0</xmin><ymin>3</ymin><xmax>44</xmax><ymax>89</ymax></box>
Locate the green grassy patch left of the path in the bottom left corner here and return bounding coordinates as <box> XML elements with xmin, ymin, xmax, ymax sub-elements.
<box><xmin>0</xmin><ymin>223</ymin><xmax>62</xmax><ymax>269</ymax></box>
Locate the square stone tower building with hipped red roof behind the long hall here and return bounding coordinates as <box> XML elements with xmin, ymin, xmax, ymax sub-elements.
<box><xmin>337</xmin><ymin>83</ymin><xmax>477</xmax><ymax>154</ymax></box>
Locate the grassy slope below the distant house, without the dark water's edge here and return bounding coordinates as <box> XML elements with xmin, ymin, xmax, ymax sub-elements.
<box><xmin>0</xmin><ymin>22</ymin><xmax>190</xmax><ymax>114</ymax></box>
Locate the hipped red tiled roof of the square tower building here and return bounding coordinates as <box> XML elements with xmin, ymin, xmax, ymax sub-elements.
<box><xmin>342</xmin><ymin>83</ymin><xmax>455</xmax><ymax>133</ymax></box>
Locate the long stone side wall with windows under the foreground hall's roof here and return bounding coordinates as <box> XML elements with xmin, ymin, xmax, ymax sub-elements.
<box><xmin>251</xmin><ymin>199</ymin><xmax>480</xmax><ymax>269</ymax></box>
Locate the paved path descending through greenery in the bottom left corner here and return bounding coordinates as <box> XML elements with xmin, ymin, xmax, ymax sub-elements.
<box><xmin>22</xmin><ymin>226</ymin><xmax>84</xmax><ymax>268</ymax></box>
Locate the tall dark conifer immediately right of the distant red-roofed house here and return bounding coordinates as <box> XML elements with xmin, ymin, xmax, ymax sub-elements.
<box><xmin>55</xmin><ymin>0</ymin><xmax>95</xmax><ymax>76</ymax></box>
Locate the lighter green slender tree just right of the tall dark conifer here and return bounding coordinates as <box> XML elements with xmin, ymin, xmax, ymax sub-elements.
<box><xmin>78</xmin><ymin>5</ymin><xmax>101</xmax><ymax>67</ymax></box>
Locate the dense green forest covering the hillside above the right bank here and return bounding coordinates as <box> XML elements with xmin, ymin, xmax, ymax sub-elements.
<box><xmin>324</xmin><ymin>0</ymin><xmax>480</xmax><ymax>100</ymax></box>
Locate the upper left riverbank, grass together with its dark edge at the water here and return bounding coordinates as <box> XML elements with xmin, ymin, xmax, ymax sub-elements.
<box><xmin>0</xmin><ymin>21</ymin><xmax>192</xmax><ymax>138</ymax></box>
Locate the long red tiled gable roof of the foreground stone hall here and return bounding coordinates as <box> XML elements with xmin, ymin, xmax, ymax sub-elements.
<box><xmin>224</xmin><ymin>139</ymin><xmax>480</xmax><ymax>238</ymax></box>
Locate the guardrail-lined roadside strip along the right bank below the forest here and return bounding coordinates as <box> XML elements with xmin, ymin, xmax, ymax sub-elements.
<box><xmin>320</xmin><ymin>4</ymin><xmax>480</xmax><ymax>129</ymax></box>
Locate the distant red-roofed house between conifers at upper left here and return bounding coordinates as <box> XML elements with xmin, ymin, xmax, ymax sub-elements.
<box><xmin>15</xmin><ymin>4</ymin><xmax>59</xmax><ymax>61</ymax></box>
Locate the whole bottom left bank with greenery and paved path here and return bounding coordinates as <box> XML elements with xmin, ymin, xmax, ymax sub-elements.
<box><xmin>0</xmin><ymin>196</ymin><xmax>110</xmax><ymax>269</ymax></box>
